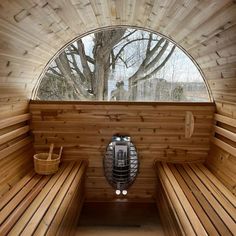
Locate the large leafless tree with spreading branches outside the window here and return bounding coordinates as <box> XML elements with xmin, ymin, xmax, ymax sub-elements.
<box><xmin>39</xmin><ymin>28</ymin><xmax>175</xmax><ymax>100</ymax></box>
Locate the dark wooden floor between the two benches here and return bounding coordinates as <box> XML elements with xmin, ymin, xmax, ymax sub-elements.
<box><xmin>76</xmin><ymin>203</ymin><xmax>164</xmax><ymax>236</ymax></box>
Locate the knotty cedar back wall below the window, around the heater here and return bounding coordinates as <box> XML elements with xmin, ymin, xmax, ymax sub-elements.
<box><xmin>30</xmin><ymin>101</ymin><xmax>215</xmax><ymax>201</ymax></box>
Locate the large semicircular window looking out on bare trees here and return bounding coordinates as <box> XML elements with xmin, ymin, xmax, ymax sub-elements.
<box><xmin>36</xmin><ymin>28</ymin><xmax>210</xmax><ymax>102</ymax></box>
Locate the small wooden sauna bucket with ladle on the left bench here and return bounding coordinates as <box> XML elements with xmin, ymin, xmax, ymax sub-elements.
<box><xmin>34</xmin><ymin>144</ymin><xmax>63</xmax><ymax>175</ymax></box>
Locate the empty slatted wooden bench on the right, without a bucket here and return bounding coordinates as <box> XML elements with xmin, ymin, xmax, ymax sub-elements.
<box><xmin>155</xmin><ymin>162</ymin><xmax>236</xmax><ymax>236</ymax></box>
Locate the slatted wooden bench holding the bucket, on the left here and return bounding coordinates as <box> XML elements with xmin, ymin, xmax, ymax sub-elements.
<box><xmin>0</xmin><ymin>161</ymin><xmax>87</xmax><ymax>236</ymax></box>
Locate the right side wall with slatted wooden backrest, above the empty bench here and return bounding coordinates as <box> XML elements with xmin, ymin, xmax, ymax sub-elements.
<box><xmin>206</xmin><ymin>103</ymin><xmax>236</xmax><ymax>195</ymax></box>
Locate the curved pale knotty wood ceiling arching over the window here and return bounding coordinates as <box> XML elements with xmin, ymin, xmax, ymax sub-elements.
<box><xmin>0</xmin><ymin>0</ymin><xmax>236</xmax><ymax>104</ymax></box>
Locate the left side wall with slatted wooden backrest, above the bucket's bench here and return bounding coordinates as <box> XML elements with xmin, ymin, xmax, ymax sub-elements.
<box><xmin>0</xmin><ymin>97</ymin><xmax>33</xmax><ymax>197</ymax></box>
